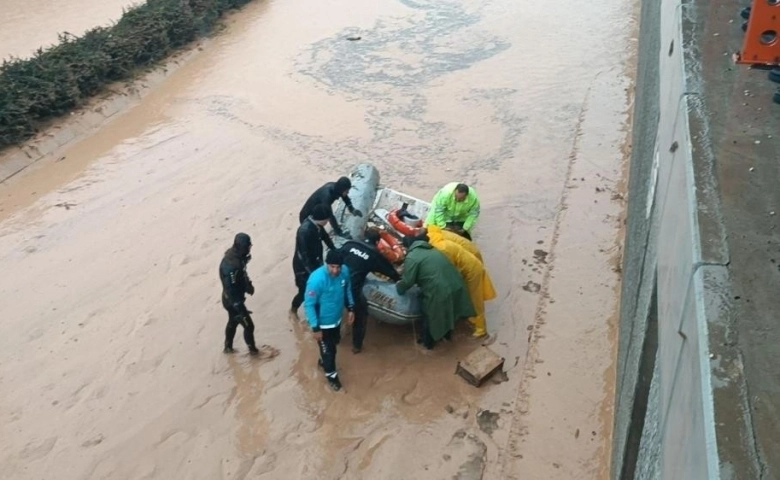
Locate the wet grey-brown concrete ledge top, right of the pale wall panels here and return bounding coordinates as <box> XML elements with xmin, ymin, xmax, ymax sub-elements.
<box><xmin>683</xmin><ymin>0</ymin><xmax>780</xmax><ymax>479</ymax></box>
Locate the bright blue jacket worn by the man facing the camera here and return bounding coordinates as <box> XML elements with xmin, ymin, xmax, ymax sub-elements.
<box><xmin>304</xmin><ymin>265</ymin><xmax>355</xmax><ymax>332</ymax></box>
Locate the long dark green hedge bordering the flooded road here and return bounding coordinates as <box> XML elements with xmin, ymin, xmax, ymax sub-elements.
<box><xmin>0</xmin><ymin>0</ymin><xmax>251</xmax><ymax>148</ymax></box>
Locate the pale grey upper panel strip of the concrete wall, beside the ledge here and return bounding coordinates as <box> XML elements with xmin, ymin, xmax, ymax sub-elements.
<box><xmin>656</xmin><ymin>0</ymin><xmax>718</xmax><ymax>480</ymax></box>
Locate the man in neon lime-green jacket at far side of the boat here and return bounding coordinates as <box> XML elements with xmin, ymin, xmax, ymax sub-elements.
<box><xmin>425</xmin><ymin>182</ymin><xmax>479</xmax><ymax>240</ymax></box>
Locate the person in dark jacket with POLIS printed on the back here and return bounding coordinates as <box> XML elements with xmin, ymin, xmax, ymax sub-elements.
<box><xmin>339</xmin><ymin>228</ymin><xmax>401</xmax><ymax>354</ymax></box>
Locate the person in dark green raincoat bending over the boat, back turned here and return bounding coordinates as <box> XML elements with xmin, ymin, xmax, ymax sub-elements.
<box><xmin>396</xmin><ymin>236</ymin><xmax>477</xmax><ymax>350</ymax></box>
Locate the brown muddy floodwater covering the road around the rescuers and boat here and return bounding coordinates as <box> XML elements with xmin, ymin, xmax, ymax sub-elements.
<box><xmin>0</xmin><ymin>0</ymin><xmax>636</xmax><ymax>479</ymax></box>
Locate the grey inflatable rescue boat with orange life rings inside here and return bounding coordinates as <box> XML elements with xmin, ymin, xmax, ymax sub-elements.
<box><xmin>333</xmin><ymin>163</ymin><xmax>430</xmax><ymax>325</ymax></box>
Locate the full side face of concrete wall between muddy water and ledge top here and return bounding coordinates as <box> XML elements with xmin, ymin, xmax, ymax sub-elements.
<box><xmin>612</xmin><ymin>0</ymin><xmax>720</xmax><ymax>480</ymax></box>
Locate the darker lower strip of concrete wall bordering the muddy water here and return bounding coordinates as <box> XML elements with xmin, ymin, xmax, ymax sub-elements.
<box><xmin>612</xmin><ymin>0</ymin><xmax>661</xmax><ymax>479</ymax></box>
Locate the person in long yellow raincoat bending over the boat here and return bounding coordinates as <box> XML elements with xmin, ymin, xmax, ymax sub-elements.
<box><xmin>421</xmin><ymin>225</ymin><xmax>496</xmax><ymax>338</ymax></box>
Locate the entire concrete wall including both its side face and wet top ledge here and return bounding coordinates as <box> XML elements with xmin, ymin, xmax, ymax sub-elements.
<box><xmin>612</xmin><ymin>0</ymin><xmax>780</xmax><ymax>479</ymax></box>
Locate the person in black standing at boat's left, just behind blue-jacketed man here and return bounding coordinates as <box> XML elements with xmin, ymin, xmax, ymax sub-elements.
<box><xmin>290</xmin><ymin>205</ymin><xmax>335</xmax><ymax>318</ymax></box>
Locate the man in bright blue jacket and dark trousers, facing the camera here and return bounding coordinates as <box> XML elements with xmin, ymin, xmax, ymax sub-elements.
<box><xmin>304</xmin><ymin>250</ymin><xmax>355</xmax><ymax>391</ymax></box>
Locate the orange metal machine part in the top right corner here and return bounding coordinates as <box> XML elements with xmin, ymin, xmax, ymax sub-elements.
<box><xmin>736</xmin><ymin>0</ymin><xmax>780</xmax><ymax>65</ymax></box>
